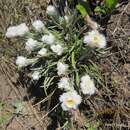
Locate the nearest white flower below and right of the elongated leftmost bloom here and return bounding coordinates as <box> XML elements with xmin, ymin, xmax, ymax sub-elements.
<box><xmin>25</xmin><ymin>38</ymin><xmax>38</xmax><ymax>51</ymax></box>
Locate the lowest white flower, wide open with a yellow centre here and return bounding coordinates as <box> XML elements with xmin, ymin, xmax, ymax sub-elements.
<box><xmin>59</xmin><ymin>90</ymin><xmax>82</xmax><ymax>111</ymax></box>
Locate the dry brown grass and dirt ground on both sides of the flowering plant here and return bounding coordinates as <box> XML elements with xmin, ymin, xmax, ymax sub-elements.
<box><xmin>0</xmin><ymin>0</ymin><xmax>130</xmax><ymax>130</ymax></box>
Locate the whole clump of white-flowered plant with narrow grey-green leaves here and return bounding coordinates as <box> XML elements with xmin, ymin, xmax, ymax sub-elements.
<box><xmin>6</xmin><ymin>5</ymin><xmax>106</xmax><ymax>128</ymax></box>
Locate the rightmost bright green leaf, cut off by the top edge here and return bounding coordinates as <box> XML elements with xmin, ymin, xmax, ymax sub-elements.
<box><xmin>105</xmin><ymin>0</ymin><xmax>118</xmax><ymax>11</ymax></box>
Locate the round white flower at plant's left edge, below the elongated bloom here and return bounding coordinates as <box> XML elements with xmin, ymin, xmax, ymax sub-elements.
<box><xmin>16</xmin><ymin>56</ymin><xmax>28</xmax><ymax>67</ymax></box>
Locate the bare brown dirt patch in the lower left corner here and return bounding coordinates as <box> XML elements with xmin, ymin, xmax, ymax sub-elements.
<box><xmin>0</xmin><ymin>59</ymin><xmax>48</xmax><ymax>130</ymax></box>
